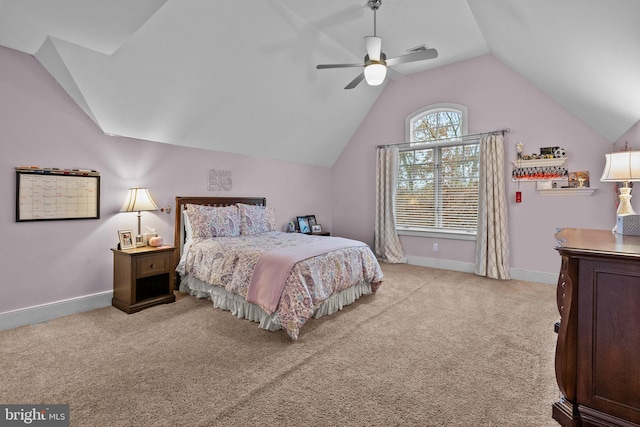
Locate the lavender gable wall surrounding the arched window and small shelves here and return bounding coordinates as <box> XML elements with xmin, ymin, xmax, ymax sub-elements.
<box><xmin>332</xmin><ymin>55</ymin><xmax>616</xmax><ymax>277</ymax></box>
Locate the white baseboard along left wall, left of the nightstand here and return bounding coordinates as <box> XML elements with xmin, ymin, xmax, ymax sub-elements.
<box><xmin>0</xmin><ymin>291</ymin><xmax>113</xmax><ymax>331</ymax></box>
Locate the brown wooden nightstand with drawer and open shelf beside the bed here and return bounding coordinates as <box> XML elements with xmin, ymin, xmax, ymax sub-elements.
<box><xmin>111</xmin><ymin>246</ymin><xmax>176</xmax><ymax>314</ymax></box>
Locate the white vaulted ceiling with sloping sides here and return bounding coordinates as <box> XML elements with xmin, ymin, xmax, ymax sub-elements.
<box><xmin>0</xmin><ymin>0</ymin><xmax>640</xmax><ymax>166</ymax></box>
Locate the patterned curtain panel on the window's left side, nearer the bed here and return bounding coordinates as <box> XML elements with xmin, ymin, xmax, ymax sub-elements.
<box><xmin>374</xmin><ymin>146</ymin><xmax>407</xmax><ymax>263</ymax></box>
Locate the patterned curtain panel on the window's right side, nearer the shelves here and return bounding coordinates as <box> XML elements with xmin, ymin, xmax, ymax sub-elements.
<box><xmin>475</xmin><ymin>134</ymin><xmax>510</xmax><ymax>279</ymax></box>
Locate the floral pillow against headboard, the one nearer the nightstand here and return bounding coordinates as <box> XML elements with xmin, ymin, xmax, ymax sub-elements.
<box><xmin>185</xmin><ymin>204</ymin><xmax>240</xmax><ymax>239</ymax></box>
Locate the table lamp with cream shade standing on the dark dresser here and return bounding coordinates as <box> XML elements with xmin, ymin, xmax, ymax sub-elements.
<box><xmin>600</xmin><ymin>151</ymin><xmax>640</xmax><ymax>232</ymax></box>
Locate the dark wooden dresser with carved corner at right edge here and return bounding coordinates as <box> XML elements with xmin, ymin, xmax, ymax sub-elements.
<box><xmin>552</xmin><ymin>228</ymin><xmax>640</xmax><ymax>426</ymax></box>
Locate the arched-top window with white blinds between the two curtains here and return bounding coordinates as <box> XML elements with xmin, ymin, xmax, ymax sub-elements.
<box><xmin>396</xmin><ymin>104</ymin><xmax>480</xmax><ymax>234</ymax></box>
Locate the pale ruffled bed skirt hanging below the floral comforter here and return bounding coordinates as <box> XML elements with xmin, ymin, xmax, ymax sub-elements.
<box><xmin>180</xmin><ymin>276</ymin><xmax>373</xmax><ymax>331</ymax></box>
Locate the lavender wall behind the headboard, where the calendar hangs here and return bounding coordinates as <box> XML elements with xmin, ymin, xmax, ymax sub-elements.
<box><xmin>0</xmin><ymin>47</ymin><xmax>332</xmax><ymax>318</ymax></box>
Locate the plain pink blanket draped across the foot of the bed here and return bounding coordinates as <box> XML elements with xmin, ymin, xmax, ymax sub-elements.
<box><xmin>247</xmin><ymin>237</ymin><xmax>366</xmax><ymax>314</ymax></box>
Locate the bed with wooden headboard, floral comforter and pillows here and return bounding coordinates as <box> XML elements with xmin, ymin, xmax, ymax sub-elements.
<box><xmin>174</xmin><ymin>197</ymin><xmax>383</xmax><ymax>340</ymax></box>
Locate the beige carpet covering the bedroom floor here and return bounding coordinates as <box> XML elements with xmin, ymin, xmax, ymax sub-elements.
<box><xmin>0</xmin><ymin>264</ymin><xmax>559</xmax><ymax>427</ymax></box>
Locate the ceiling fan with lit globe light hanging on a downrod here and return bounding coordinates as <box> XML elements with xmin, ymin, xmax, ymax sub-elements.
<box><xmin>316</xmin><ymin>0</ymin><xmax>438</xmax><ymax>89</ymax></box>
